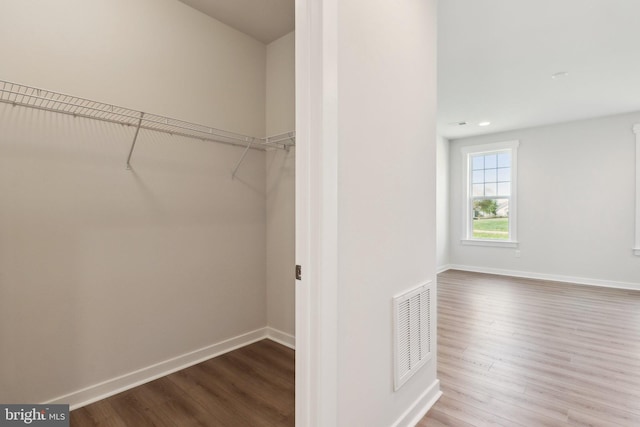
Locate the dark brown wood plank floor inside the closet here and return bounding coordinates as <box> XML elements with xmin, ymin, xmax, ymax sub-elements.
<box><xmin>70</xmin><ymin>340</ymin><xmax>295</xmax><ymax>427</ymax></box>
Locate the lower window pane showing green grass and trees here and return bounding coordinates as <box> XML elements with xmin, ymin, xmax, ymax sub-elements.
<box><xmin>473</xmin><ymin>198</ymin><xmax>509</xmax><ymax>240</ymax></box>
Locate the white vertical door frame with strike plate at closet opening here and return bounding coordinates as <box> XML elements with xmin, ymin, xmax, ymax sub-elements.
<box><xmin>295</xmin><ymin>0</ymin><xmax>339</xmax><ymax>427</ymax></box>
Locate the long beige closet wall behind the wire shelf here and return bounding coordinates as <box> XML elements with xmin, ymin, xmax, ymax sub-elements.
<box><xmin>0</xmin><ymin>0</ymin><xmax>276</xmax><ymax>403</ymax></box>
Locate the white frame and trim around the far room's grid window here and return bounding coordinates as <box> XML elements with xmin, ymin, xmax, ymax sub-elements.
<box><xmin>460</xmin><ymin>140</ymin><xmax>520</xmax><ymax>248</ymax></box>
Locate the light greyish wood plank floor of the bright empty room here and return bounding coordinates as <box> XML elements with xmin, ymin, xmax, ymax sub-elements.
<box><xmin>418</xmin><ymin>270</ymin><xmax>640</xmax><ymax>427</ymax></box>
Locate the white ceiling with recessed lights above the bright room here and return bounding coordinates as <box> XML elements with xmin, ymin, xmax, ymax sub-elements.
<box><xmin>438</xmin><ymin>0</ymin><xmax>640</xmax><ymax>138</ymax></box>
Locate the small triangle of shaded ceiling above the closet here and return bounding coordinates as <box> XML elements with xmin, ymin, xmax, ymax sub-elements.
<box><xmin>180</xmin><ymin>0</ymin><xmax>295</xmax><ymax>44</ymax></box>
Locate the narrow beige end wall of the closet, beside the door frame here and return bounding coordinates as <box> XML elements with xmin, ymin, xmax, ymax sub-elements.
<box><xmin>266</xmin><ymin>32</ymin><xmax>296</xmax><ymax>342</ymax></box>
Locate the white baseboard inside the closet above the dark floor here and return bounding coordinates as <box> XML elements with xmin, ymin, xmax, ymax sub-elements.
<box><xmin>44</xmin><ymin>327</ymin><xmax>282</xmax><ymax>410</ymax></box>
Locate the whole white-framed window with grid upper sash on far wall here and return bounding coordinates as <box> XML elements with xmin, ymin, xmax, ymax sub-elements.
<box><xmin>462</xmin><ymin>141</ymin><xmax>519</xmax><ymax>247</ymax></box>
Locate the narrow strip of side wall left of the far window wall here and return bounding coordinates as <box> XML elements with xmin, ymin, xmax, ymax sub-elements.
<box><xmin>436</xmin><ymin>136</ymin><xmax>450</xmax><ymax>271</ymax></box>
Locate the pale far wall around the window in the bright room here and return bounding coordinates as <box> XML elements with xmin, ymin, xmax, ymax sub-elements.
<box><xmin>450</xmin><ymin>113</ymin><xmax>640</xmax><ymax>287</ymax></box>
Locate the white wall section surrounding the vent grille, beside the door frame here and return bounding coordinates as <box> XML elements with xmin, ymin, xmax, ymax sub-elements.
<box><xmin>336</xmin><ymin>0</ymin><xmax>437</xmax><ymax>427</ymax></box>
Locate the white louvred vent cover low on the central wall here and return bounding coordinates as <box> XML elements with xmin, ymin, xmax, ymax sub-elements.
<box><xmin>393</xmin><ymin>282</ymin><xmax>431</xmax><ymax>390</ymax></box>
